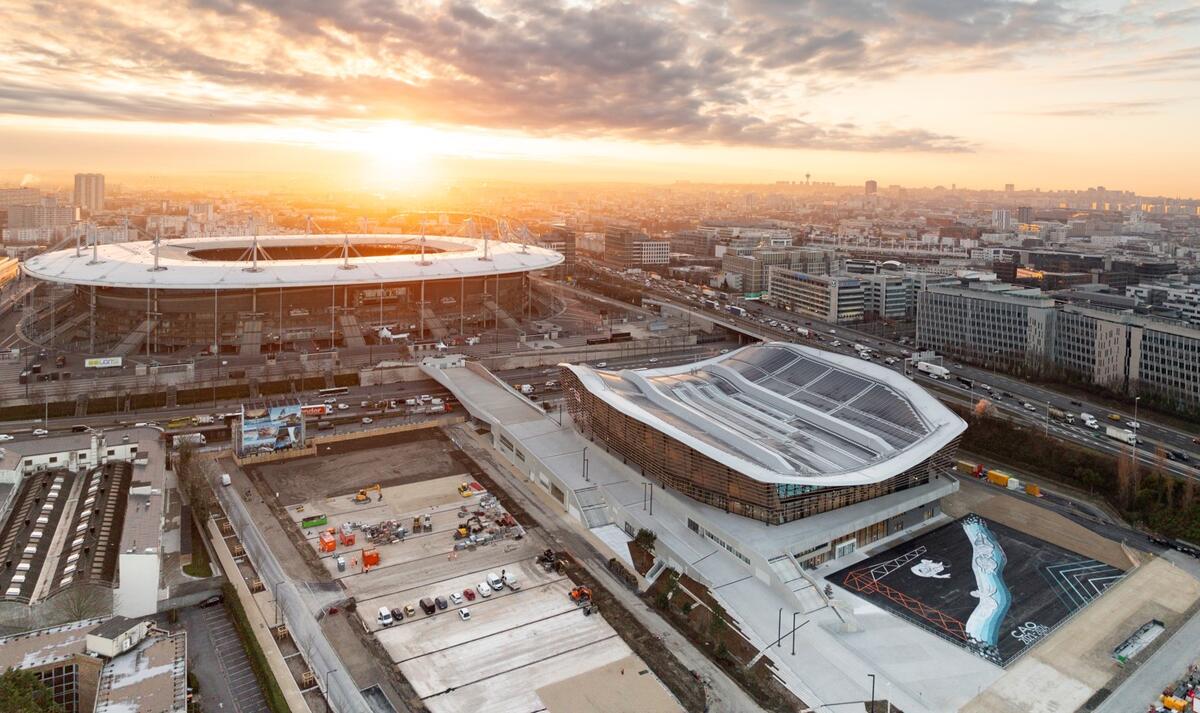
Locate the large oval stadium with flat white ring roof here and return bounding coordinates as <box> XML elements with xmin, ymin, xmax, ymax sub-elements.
<box><xmin>23</xmin><ymin>234</ymin><xmax>563</xmax><ymax>357</ymax></box>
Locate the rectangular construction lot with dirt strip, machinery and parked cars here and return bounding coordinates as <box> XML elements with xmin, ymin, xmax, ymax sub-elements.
<box><xmin>257</xmin><ymin>429</ymin><xmax>682</xmax><ymax>713</ymax></box>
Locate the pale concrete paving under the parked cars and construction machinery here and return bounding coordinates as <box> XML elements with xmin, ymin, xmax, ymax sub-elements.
<box><xmin>279</xmin><ymin>465</ymin><xmax>679</xmax><ymax>713</ymax></box>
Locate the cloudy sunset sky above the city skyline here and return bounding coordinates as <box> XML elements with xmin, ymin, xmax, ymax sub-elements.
<box><xmin>0</xmin><ymin>0</ymin><xmax>1200</xmax><ymax>196</ymax></box>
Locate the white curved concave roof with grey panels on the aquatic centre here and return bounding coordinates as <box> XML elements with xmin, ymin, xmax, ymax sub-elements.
<box><xmin>566</xmin><ymin>342</ymin><xmax>966</xmax><ymax>486</ymax></box>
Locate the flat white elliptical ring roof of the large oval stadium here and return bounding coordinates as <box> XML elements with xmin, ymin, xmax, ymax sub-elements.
<box><xmin>22</xmin><ymin>234</ymin><xmax>563</xmax><ymax>289</ymax></box>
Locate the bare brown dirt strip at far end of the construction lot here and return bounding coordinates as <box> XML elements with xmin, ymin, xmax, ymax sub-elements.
<box><xmin>247</xmin><ymin>429</ymin><xmax>468</xmax><ymax>507</ymax></box>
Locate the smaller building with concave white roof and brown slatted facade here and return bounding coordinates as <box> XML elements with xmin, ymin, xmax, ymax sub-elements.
<box><xmin>563</xmin><ymin>342</ymin><xmax>966</xmax><ymax>532</ymax></box>
